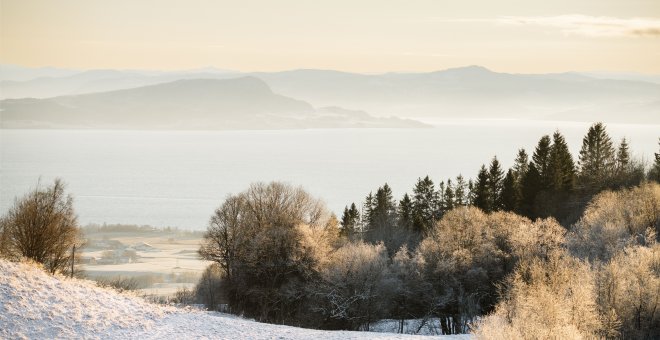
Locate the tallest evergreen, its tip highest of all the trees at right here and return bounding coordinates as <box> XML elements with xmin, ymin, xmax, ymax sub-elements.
<box><xmin>578</xmin><ymin>123</ymin><xmax>616</xmax><ymax>192</ymax></box>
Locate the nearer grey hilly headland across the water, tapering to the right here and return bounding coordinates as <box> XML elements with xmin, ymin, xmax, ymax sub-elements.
<box><xmin>0</xmin><ymin>76</ymin><xmax>425</xmax><ymax>129</ymax></box>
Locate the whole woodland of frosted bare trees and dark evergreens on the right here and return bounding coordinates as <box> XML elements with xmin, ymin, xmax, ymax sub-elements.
<box><xmin>191</xmin><ymin>123</ymin><xmax>660</xmax><ymax>339</ymax></box>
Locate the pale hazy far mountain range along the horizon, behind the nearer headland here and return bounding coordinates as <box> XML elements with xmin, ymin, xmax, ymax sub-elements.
<box><xmin>0</xmin><ymin>66</ymin><xmax>660</xmax><ymax>124</ymax></box>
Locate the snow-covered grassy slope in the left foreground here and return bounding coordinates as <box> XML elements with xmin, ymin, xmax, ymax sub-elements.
<box><xmin>0</xmin><ymin>260</ymin><xmax>468</xmax><ymax>339</ymax></box>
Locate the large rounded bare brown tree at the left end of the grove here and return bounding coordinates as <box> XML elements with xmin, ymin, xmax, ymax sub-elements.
<box><xmin>199</xmin><ymin>182</ymin><xmax>337</xmax><ymax>322</ymax></box>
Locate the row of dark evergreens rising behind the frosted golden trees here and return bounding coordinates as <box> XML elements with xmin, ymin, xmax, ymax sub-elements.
<box><xmin>341</xmin><ymin>123</ymin><xmax>660</xmax><ymax>239</ymax></box>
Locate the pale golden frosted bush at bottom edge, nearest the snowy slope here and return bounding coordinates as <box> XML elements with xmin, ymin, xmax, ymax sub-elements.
<box><xmin>474</xmin><ymin>251</ymin><xmax>602</xmax><ymax>339</ymax></box>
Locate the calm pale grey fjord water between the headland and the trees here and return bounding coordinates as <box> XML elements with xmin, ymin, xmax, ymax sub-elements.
<box><xmin>0</xmin><ymin>121</ymin><xmax>660</xmax><ymax>229</ymax></box>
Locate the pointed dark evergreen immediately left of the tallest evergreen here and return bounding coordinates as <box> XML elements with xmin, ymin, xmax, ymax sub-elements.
<box><xmin>548</xmin><ymin>131</ymin><xmax>575</xmax><ymax>193</ymax></box>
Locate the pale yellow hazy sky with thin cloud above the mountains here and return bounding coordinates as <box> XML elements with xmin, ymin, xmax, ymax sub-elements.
<box><xmin>0</xmin><ymin>0</ymin><xmax>660</xmax><ymax>73</ymax></box>
